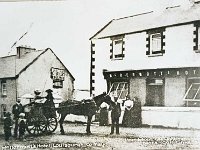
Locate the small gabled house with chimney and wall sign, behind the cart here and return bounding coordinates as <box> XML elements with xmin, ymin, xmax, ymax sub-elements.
<box><xmin>0</xmin><ymin>46</ymin><xmax>75</xmax><ymax>117</ymax></box>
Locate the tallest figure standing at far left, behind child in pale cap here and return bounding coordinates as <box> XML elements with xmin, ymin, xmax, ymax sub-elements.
<box><xmin>12</xmin><ymin>98</ymin><xmax>24</xmax><ymax>138</ymax></box>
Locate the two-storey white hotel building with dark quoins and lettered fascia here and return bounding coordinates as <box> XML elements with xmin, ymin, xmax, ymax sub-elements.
<box><xmin>90</xmin><ymin>1</ymin><xmax>200</xmax><ymax>128</ymax></box>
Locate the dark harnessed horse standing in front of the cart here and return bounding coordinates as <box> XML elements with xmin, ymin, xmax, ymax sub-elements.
<box><xmin>57</xmin><ymin>93</ymin><xmax>111</xmax><ymax>134</ymax></box>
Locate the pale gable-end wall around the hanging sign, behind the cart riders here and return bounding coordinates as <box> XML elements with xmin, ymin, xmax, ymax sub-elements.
<box><xmin>17</xmin><ymin>50</ymin><xmax>74</xmax><ymax>100</ymax></box>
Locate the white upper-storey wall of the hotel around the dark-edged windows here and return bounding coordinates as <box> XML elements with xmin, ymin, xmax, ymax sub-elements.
<box><xmin>93</xmin><ymin>24</ymin><xmax>200</xmax><ymax>94</ymax></box>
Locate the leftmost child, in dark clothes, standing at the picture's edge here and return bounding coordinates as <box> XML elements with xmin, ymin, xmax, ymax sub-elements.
<box><xmin>4</xmin><ymin>112</ymin><xmax>12</xmax><ymax>141</ymax></box>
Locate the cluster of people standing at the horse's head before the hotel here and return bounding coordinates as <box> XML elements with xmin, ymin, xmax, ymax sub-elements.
<box><xmin>99</xmin><ymin>93</ymin><xmax>141</xmax><ymax>135</ymax></box>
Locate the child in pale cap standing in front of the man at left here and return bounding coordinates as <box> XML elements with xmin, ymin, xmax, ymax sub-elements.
<box><xmin>19</xmin><ymin>113</ymin><xmax>26</xmax><ymax>140</ymax></box>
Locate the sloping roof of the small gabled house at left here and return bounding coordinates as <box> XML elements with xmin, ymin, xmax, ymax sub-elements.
<box><xmin>0</xmin><ymin>48</ymin><xmax>75</xmax><ymax>80</ymax></box>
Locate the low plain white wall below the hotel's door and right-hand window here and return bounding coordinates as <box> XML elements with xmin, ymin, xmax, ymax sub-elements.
<box><xmin>142</xmin><ymin>107</ymin><xmax>200</xmax><ymax>129</ymax></box>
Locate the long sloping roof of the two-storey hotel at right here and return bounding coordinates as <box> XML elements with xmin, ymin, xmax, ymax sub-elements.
<box><xmin>90</xmin><ymin>4</ymin><xmax>200</xmax><ymax>39</ymax></box>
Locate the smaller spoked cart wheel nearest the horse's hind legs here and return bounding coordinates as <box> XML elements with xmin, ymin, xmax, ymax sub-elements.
<box><xmin>45</xmin><ymin>117</ymin><xmax>58</xmax><ymax>134</ymax></box>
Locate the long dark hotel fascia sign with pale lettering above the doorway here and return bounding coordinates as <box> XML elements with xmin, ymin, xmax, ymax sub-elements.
<box><xmin>103</xmin><ymin>67</ymin><xmax>200</xmax><ymax>79</ymax></box>
